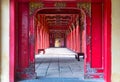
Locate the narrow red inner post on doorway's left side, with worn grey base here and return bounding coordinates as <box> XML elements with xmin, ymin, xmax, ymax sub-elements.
<box><xmin>27</xmin><ymin>6</ymin><xmax>36</xmax><ymax>79</ymax></box>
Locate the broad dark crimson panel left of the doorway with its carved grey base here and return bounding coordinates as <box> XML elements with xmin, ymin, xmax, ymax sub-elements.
<box><xmin>16</xmin><ymin>3</ymin><xmax>36</xmax><ymax>79</ymax></box>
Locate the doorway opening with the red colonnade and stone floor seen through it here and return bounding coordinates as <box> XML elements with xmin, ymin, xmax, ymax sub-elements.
<box><xmin>34</xmin><ymin>9</ymin><xmax>85</xmax><ymax>79</ymax></box>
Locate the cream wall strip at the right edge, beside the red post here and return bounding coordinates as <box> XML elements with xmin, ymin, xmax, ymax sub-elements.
<box><xmin>112</xmin><ymin>0</ymin><xmax>120</xmax><ymax>82</ymax></box>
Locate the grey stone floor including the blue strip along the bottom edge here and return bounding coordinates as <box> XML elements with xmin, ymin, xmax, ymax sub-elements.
<box><xmin>18</xmin><ymin>48</ymin><xmax>104</xmax><ymax>82</ymax></box>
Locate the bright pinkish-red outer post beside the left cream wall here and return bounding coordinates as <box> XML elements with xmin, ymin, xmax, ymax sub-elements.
<box><xmin>9</xmin><ymin>0</ymin><xmax>15</xmax><ymax>82</ymax></box>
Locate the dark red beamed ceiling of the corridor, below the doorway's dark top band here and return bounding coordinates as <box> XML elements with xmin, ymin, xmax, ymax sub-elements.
<box><xmin>45</xmin><ymin>14</ymin><xmax>75</xmax><ymax>30</ymax></box>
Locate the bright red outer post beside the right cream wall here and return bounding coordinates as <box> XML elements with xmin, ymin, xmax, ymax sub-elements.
<box><xmin>103</xmin><ymin>0</ymin><xmax>111</xmax><ymax>82</ymax></box>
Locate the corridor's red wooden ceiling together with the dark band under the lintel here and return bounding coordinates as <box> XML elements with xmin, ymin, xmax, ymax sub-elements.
<box><xmin>38</xmin><ymin>8</ymin><xmax>80</xmax><ymax>31</ymax></box>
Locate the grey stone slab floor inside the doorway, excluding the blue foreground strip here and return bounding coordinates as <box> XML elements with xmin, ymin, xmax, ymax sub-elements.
<box><xmin>35</xmin><ymin>48</ymin><xmax>84</xmax><ymax>79</ymax></box>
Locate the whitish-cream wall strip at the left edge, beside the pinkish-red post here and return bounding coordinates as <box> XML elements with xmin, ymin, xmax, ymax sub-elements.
<box><xmin>0</xmin><ymin>0</ymin><xmax>9</xmax><ymax>82</ymax></box>
